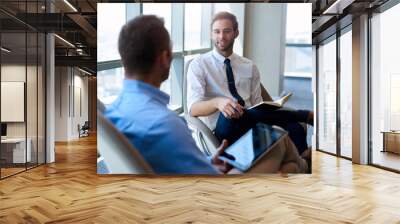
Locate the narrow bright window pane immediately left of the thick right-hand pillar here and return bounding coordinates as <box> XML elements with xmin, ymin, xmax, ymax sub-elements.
<box><xmin>340</xmin><ymin>31</ymin><xmax>353</xmax><ymax>158</ymax></box>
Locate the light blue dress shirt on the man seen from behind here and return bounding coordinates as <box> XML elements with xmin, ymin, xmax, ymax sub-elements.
<box><xmin>105</xmin><ymin>80</ymin><xmax>218</xmax><ymax>174</ymax></box>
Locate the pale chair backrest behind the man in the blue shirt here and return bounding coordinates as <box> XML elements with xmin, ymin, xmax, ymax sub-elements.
<box><xmin>97</xmin><ymin>101</ymin><xmax>153</xmax><ymax>174</ymax></box>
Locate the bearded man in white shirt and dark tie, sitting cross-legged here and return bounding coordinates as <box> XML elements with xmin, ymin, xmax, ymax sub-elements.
<box><xmin>187</xmin><ymin>12</ymin><xmax>313</xmax><ymax>153</ymax></box>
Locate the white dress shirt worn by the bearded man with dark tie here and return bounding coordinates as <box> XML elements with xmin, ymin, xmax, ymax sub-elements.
<box><xmin>187</xmin><ymin>49</ymin><xmax>262</xmax><ymax>130</ymax></box>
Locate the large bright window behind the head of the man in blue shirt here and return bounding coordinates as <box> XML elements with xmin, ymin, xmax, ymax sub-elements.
<box><xmin>97</xmin><ymin>3</ymin><xmax>212</xmax><ymax>111</ymax></box>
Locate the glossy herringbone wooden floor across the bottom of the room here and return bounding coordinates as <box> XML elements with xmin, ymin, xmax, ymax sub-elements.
<box><xmin>0</xmin><ymin>134</ymin><xmax>400</xmax><ymax>224</ymax></box>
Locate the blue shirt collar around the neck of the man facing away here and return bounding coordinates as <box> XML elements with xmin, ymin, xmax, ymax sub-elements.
<box><xmin>122</xmin><ymin>79</ymin><xmax>169</xmax><ymax>106</ymax></box>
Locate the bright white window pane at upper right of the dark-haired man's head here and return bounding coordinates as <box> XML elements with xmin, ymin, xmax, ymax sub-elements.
<box><xmin>143</xmin><ymin>3</ymin><xmax>171</xmax><ymax>35</ymax></box>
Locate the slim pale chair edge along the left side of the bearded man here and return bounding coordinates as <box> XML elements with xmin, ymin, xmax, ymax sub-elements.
<box><xmin>182</xmin><ymin>59</ymin><xmax>220</xmax><ymax>155</ymax></box>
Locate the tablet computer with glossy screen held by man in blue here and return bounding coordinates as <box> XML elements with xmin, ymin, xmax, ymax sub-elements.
<box><xmin>219</xmin><ymin>124</ymin><xmax>287</xmax><ymax>172</ymax></box>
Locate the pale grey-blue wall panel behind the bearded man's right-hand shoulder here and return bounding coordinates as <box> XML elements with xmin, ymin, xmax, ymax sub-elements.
<box><xmin>244</xmin><ymin>4</ymin><xmax>286</xmax><ymax>95</ymax></box>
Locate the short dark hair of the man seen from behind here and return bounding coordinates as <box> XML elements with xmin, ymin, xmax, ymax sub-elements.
<box><xmin>118</xmin><ymin>15</ymin><xmax>170</xmax><ymax>74</ymax></box>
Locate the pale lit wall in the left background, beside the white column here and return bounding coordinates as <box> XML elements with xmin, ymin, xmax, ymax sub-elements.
<box><xmin>55</xmin><ymin>67</ymin><xmax>88</xmax><ymax>141</ymax></box>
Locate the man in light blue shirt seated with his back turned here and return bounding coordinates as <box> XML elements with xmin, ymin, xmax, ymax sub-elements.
<box><xmin>105</xmin><ymin>16</ymin><xmax>231</xmax><ymax>174</ymax></box>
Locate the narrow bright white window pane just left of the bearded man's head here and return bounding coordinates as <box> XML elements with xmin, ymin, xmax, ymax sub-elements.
<box><xmin>185</xmin><ymin>3</ymin><xmax>202</xmax><ymax>50</ymax></box>
